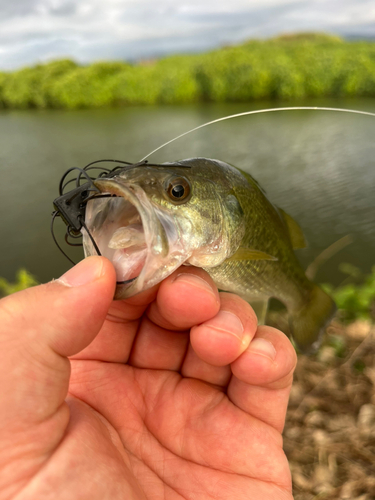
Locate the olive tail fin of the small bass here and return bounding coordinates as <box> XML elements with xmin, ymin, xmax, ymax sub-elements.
<box><xmin>289</xmin><ymin>285</ymin><xmax>336</xmax><ymax>354</ymax></box>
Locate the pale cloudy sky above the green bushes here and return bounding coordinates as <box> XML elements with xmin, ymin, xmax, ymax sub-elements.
<box><xmin>0</xmin><ymin>0</ymin><xmax>375</xmax><ymax>70</ymax></box>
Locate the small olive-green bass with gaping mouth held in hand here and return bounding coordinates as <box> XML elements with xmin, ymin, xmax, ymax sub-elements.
<box><xmin>82</xmin><ymin>158</ymin><xmax>336</xmax><ymax>353</ymax></box>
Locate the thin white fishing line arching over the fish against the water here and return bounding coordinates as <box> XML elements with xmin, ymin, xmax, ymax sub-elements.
<box><xmin>141</xmin><ymin>106</ymin><xmax>375</xmax><ymax>162</ymax></box>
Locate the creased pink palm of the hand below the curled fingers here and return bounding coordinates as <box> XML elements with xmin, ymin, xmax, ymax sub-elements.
<box><xmin>67</xmin><ymin>361</ymin><xmax>290</xmax><ymax>500</ymax></box>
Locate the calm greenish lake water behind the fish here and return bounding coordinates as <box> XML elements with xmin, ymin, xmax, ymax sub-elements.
<box><xmin>0</xmin><ymin>99</ymin><xmax>375</xmax><ymax>285</ymax></box>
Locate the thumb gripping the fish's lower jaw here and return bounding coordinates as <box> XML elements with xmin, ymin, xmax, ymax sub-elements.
<box><xmin>0</xmin><ymin>257</ymin><xmax>116</xmax><ymax>433</ymax></box>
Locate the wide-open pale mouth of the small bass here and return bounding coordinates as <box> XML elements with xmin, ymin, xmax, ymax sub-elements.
<box><xmin>82</xmin><ymin>179</ymin><xmax>169</xmax><ymax>299</ymax></box>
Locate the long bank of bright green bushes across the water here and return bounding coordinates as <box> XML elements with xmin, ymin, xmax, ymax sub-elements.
<box><xmin>0</xmin><ymin>33</ymin><xmax>375</xmax><ymax>109</ymax></box>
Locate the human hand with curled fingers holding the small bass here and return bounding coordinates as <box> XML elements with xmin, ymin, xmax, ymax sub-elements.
<box><xmin>0</xmin><ymin>257</ymin><xmax>296</xmax><ymax>500</ymax></box>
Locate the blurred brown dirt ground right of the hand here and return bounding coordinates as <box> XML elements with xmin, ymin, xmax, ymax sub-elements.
<box><xmin>284</xmin><ymin>322</ymin><xmax>375</xmax><ymax>500</ymax></box>
